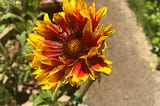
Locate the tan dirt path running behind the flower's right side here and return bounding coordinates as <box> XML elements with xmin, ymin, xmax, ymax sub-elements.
<box><xmin>86</xmin><ymin>0</ymin><xmax>160</xmax><ymax>106</ymax></box>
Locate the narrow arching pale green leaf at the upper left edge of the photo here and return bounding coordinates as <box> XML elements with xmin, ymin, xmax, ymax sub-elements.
<box><xmin>1</xmin><ymin>12</ymin><xmax>24</xmax><ymax>21</ymax></box>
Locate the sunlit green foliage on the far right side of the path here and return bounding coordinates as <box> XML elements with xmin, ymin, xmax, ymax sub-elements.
<box><xmin>128</xmin><ymin>0</ymin><xmax>160</xmax><ymax>66</ymax></box>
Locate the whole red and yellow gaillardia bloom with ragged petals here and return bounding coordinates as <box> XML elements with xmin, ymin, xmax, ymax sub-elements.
<box><xmin>26</xmin><ymin>0</ymin><xmax>115</xmax><ymax>91</ymax></box>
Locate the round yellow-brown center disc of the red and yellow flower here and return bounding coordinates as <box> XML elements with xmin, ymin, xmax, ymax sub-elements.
<box><xmin>64</xmin><ymin>38</ymin><xmax>82</xmax><ymax>58</ymax></box>
